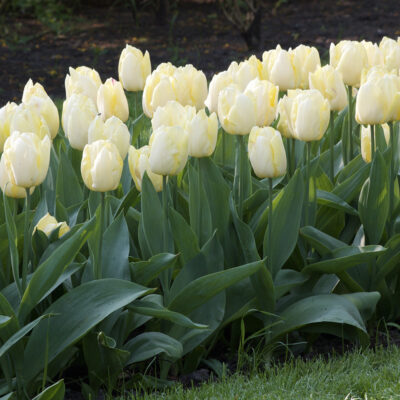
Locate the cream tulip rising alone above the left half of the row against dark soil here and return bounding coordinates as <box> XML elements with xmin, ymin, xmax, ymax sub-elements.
<box><xmin>118</xmin><ymin>44</ymin><xmax>151</xmax><ymax>92</ymax></box>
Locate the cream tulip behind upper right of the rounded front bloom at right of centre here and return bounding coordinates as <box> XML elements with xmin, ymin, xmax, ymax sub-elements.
<box><xmin>309</xmin><ymin>65</ymin><xmax>348</xmax><ymax>111</ymax></box>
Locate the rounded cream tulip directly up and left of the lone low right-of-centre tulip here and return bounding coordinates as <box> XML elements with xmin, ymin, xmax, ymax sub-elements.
<box><xmin>218</xmin><ymin>85</ymin><xmax>257</xmax><ymax>135</ymax></box>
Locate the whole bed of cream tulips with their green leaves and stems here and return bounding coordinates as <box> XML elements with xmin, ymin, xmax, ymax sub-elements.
<box><xmin>0</xmin><ymin>38</ymin><xmax>400</xmax><ymax>399</ymax></box>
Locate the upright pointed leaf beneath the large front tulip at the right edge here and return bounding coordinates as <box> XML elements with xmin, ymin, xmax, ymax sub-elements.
<box><xmin>358</xmin><ymin>150</ymin><xmax>389</xmax><ymax>244</ymax></box>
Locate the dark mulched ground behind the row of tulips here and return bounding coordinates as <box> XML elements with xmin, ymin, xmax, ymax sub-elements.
<box><xmin>0</xmin><ymin>0</ymin><xmax>400</xmax><ymax>106</ymax></box>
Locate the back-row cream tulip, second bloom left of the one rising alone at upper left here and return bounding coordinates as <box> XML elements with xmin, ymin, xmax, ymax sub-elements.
<box><xmin>65</xmin><ymin>66</ymin><xmax>101</xmax><ymax>104</ymax></box>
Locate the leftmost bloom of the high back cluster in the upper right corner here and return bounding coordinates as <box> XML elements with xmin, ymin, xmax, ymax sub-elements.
<box><xmin>329</xmin><ymin>40</ymin><xmax>368</xmax><ymax>87</ymax></box>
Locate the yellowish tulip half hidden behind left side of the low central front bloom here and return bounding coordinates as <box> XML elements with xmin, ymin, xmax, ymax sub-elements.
<box><xmin>128</xmin><ymin>146</ymin><xmax>163</xmax><ymax>192</ymax></box>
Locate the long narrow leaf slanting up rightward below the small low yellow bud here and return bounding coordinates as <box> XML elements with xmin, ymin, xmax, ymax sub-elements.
<box><xmin>18</xmin><ymin>218</ymin><xmax>96</xmax><ymax>321</ymax></box>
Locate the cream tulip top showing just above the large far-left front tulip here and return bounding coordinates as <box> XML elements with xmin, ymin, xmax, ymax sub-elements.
<box><xmin>10</xmin><ymin>103</ymin><xmax>51</xmax><ymax>139</ymax></box>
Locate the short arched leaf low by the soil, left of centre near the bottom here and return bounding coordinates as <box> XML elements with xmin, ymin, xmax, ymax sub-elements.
<box><xmin>124</xmin><ymin>332</ymin><xmax>183</xmax><ymax>365</ymax></box>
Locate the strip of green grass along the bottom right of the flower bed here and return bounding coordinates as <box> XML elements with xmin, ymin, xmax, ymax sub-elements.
<box><xmin>118</xmin><ymin>347</ymin><xmax>400</xmax><ymax>400</ymax></box>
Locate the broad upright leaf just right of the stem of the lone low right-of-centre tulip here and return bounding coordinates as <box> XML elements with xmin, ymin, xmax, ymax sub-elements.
<box><xmin>263</xmin><ymin>170</ymin><xmax>304</xmax><ymax>277</ymax></box>
